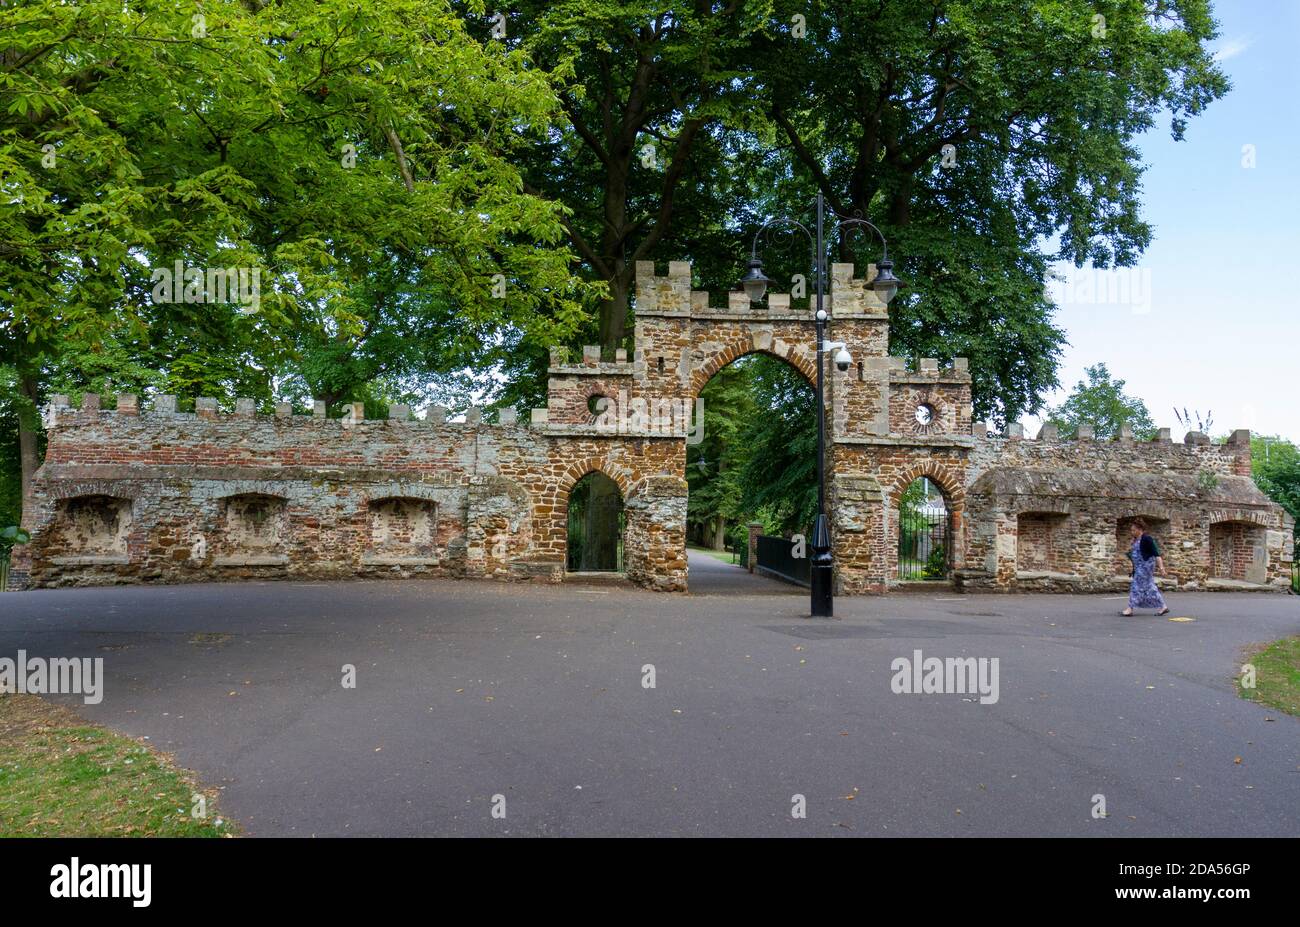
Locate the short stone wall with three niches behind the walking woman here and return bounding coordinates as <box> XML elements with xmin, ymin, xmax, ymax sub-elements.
<box><xmin>957</xmin><ymin>426</ymin><xmax>1295</xmax><ymax>592</ymax></box>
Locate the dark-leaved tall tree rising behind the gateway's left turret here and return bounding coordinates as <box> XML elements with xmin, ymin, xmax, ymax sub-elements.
<box><xmin>499</xmin><ymin>0</ymin><xmax>767</xmax><ymax>351</ymax></box>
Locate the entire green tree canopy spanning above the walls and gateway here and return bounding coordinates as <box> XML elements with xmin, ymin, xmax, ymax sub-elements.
<box><xmin>0</xmin><ymin>0</ymin><xmax>1227</xmax><ymax>530</ymax></box>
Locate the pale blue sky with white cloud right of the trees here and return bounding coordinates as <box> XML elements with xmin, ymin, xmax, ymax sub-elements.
<box><xmin>1028</xmin><ymin>0</ymin><xmax>1300</xmax><ymax>442</ymax></box>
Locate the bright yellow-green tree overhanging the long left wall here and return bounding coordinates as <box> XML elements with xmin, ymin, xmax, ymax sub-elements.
<box><xmin>0</xmin><ymin>0</ymin><xmax>584</xmax><ymax>507</ymax></box>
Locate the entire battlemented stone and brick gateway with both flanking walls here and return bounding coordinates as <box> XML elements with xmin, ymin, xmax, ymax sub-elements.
<box><xmin>12</xmin><ymin>263</ymin><xmax>1294</xmax><ymax>593</ymax></box>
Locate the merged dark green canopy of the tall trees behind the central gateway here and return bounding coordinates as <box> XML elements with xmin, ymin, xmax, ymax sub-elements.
<box><xmin>484</xmin><ymin>0</ymin><xmax>1229</xmax><ymax>421</ymax></box>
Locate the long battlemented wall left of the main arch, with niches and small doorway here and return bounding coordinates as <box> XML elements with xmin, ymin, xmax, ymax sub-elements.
<box><xmin>18</xmin><ymin>400</ymin><xmax>685</xmax><ymax>589</ymax></box>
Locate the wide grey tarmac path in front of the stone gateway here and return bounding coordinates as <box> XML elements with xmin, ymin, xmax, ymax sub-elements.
<box><xmin>0</xmin><ymin>556</ymin><xmax>1300</xmax><ymax>837</ymax></box>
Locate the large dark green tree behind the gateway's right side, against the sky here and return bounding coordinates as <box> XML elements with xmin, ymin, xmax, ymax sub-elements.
<box><xmin>745</xmin><ymin>0</ymin><xmax>1229</xmax><ymax>420</ymax></box>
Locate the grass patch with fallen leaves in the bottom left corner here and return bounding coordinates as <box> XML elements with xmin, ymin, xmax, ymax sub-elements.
<box><xmin>0</xmin><ymin>694</ymin><xmax>235</xmax><ymax>837</ymax></box>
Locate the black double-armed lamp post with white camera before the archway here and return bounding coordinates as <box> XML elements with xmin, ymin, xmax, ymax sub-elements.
<box><xmin>740</xmin><ymin>192</ymin><xmax>901</xmax><ymax>618</ymax></box>
